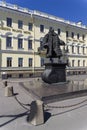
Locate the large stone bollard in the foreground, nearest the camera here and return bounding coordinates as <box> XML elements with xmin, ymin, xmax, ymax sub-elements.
<box><xmin>29</xmin><ymin>100</ymin><xmax>44</xmax><ymax>125</ymax></box>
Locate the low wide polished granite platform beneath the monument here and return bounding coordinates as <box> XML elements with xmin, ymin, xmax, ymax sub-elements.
<box><xmin>20</xmin><ymin>79</ymin><xmax>87</xmax><ymax>103</ymax></box>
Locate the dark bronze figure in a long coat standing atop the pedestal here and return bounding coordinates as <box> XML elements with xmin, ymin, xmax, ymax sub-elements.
<box><xmin>42</xmin><ymin>27</ymin><xmax>65</xmax><ymax>58</ymax></box>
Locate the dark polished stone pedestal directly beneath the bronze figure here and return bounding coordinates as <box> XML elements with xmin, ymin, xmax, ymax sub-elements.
<box><xmin>42</xmin><ymin>58</ymin><xmax>67</xmax><ymax>83</ymax></box>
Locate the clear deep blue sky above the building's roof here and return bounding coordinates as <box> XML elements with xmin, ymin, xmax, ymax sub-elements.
<box><xmin>2</xmin><ymin>0</ymin><xmax>87</xmax><ymax>25</ymax></box>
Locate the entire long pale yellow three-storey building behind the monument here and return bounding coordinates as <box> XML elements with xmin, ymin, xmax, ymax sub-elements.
<box><xmin>0</xmin><ymin>1</ymin><xmax>87</xmax><ymax>78</ymax></box>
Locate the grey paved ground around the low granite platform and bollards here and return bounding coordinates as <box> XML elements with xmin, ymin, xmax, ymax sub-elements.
<box><xmin>0</xmin><ymin>75</ymin><xmax>87</xmax><ymax>130</ymax></box>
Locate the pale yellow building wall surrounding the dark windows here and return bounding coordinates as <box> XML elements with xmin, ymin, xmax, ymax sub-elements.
<box><xmin>0</xmin><ymin>3</ymin><xmax>87</xmax><ymax>77</ymax></box>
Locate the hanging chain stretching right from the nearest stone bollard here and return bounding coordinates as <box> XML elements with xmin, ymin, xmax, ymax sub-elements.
<box><xmin>44</xmin><ymin>99</ymin><xmax>87</xmax><ymax>109</ymax></box>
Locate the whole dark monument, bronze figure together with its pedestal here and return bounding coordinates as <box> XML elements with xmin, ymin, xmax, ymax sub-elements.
<box><xmin>38</xmin><ymin>27</ymin><xmax>67</xmax><ymax>84</ymax></box>
